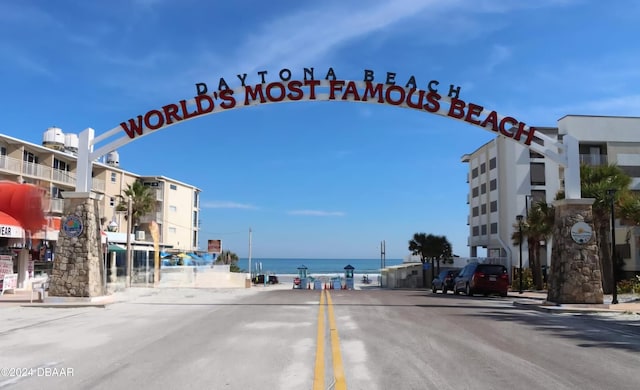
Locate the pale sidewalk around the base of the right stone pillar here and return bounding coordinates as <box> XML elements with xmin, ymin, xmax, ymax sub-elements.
<box><xmin>508</xmin><ymin>291</ymin><xmax>640</xmax><ymax>315</ymax></box>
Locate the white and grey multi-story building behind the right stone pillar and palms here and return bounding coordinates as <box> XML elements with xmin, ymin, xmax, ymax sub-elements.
<box><xmin>462</xmin><ymin>115</ymin><xmax>640</xmax><ymax>273</ymax></box>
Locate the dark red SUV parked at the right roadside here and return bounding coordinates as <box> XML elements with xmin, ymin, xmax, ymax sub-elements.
<box><xmin>453</xmin><ymin>263</ymin><xmax>509</xmax><ymax>297</ymax></box>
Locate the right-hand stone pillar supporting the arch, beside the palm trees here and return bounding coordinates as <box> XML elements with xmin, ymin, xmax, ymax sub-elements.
<box><xmin>547</xmin><ymin>199</ymin><xmax>604</xmax><ymax>304</ymax></box>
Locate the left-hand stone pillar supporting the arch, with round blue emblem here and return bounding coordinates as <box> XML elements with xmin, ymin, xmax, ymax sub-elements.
<box><xmin>49</xmin><ymin>192</ymin><xmax>104</xmax><ymax>297</ymax></box>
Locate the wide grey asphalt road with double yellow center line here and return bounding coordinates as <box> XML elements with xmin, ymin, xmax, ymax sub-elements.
<box><xmin>0</xmin><ymin>288</ymin><xmax>640</xmax><ymax>390</ymax></box>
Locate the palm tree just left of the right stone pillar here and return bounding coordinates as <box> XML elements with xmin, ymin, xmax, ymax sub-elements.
<box><xmin>511</xmin><ymin>201</ymin><xmax>555</xmax><ymax>290</ymax></box>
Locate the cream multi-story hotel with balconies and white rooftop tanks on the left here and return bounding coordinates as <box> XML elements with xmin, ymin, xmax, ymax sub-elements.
<box><xmin>0</xmin><ymin>127</ymin><xmax>200</xmax><ymax>260</ymax></box>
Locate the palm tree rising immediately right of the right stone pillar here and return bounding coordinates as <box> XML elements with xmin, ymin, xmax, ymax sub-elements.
<box><xmin>580</xmin><ymin>165</ymin><xmax>631</xmax><ymax>294</ymax></box>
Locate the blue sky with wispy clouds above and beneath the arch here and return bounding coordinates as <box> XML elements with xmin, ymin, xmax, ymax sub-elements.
<box><xmin>0</xmin><ymin>0</ymin><xmax>640</xmax><ymax>258</ymax></box>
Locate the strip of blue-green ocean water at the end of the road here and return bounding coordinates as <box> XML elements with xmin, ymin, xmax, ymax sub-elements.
<box><xmin>238</xmin><ymin>258</ymin><xmax>402</xmax><ymax>275</ymax></box>
